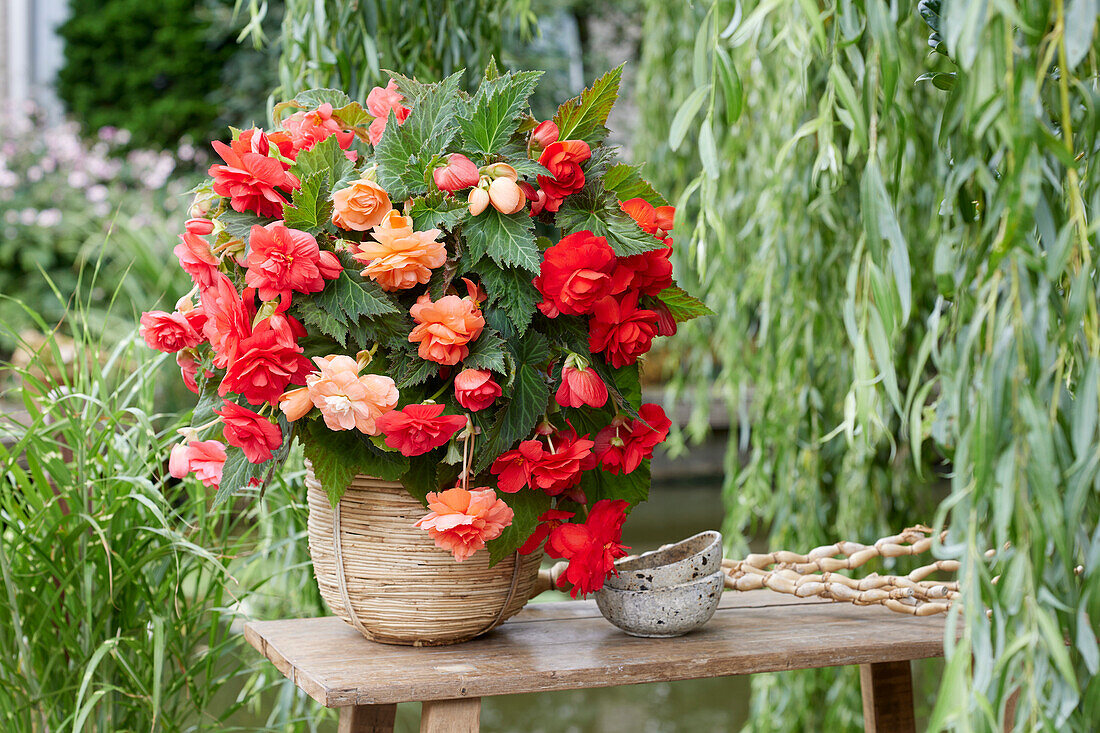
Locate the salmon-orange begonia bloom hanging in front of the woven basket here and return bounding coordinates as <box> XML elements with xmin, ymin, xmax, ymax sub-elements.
<box><xmin>414</xmin><ymin>488</ymin><xmax>513</xmax><ymax>562</ymax></box>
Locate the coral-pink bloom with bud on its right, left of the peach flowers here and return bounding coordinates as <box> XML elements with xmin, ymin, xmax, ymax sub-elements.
<box><xmin>244</xmin><ymin>221</ymin><xmax>343</xmax><ymax>300</ymax></box>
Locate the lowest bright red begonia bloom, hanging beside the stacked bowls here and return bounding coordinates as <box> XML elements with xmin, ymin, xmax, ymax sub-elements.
<box><xmin>547</xmin><ymin>499</ymin><xmax>629</xmax><ymax>599</ymax></box>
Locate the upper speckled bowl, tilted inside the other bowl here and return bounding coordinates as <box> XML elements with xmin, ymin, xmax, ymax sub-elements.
<box><xmin>604</xmin><ymin>529</ymin><xmax>722</xmax><ymax>591</ymax></box>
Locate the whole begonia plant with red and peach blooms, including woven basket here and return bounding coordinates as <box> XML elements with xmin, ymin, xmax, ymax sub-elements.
<box><xmin>141</xmin><ymin>64</ymin><xmax>707</xmax><ymax>644</ymax></box>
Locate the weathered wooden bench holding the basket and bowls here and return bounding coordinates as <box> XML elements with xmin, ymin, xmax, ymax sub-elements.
<box><xmin>244</xmin><ymin>591</ymin><xmax>944</xmax><ymax>733</ymax></box>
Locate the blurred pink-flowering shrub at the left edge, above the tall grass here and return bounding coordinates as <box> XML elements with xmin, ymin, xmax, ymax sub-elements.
<box><xmin>0</xmin><ymin>109</ymin><xmax>194</xmax><ymax>351</ymax></box>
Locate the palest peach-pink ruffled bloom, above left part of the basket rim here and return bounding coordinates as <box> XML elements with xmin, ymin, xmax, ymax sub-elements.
<box><xmin>305</xmin><ymin>354</ymin><xmax>399</xmax><ymax>435</ymax></box>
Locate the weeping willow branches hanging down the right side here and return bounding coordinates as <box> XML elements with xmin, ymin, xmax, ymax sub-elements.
<box><xmin>636</xmin><ymin>0</ymin><xmax>1100</xmax><ymax>731</ymax></box>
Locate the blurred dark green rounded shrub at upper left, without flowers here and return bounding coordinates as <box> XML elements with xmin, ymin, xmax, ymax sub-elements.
<box><xmin>57</xmin><ymin>0</ymin><xmax>278</xmax><ymax>149</ymax></box>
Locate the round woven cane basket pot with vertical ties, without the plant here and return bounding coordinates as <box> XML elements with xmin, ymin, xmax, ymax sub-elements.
<box><xmin>306</xmin><ymin>470</ymin><xmax>542</xmax><ymax>646</ymax></box>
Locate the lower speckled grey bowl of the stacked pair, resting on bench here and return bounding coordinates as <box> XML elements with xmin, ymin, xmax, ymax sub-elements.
<box><xmin>596</xmin><ymin>570</ymin><xmax>725</xmax><ymax>637</ymax></box>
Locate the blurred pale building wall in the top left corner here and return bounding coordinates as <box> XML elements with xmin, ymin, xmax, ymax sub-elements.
<box><xmin>0</xmin><ymin>0</ymin><xmax>68</xmax><ymax>117</ymax></box>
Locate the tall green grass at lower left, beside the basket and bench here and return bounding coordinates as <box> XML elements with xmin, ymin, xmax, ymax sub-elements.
<box><xmin>0</xmin><ymin>292</ymin><xmax>317</xmax><ymax>733</ymax></box>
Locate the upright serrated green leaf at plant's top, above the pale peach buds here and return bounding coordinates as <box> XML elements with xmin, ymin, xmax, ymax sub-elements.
<box><xmin>458</xmin><ymin>72</ymin><xmax>542</xmax><ymax>155</ymax></box>
